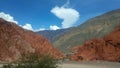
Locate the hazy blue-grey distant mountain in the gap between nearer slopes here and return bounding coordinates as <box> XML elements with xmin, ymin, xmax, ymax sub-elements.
<box><xmin>36</xmin><ymin>28</ymin><xmax>72</xmax><ymax>42</ymax></box>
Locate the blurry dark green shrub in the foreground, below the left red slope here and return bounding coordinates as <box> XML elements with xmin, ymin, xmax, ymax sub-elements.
<box><xmin>3</xmin><ymin>54</ymin><xmax>59</xmax><ymax>68</ymax></box>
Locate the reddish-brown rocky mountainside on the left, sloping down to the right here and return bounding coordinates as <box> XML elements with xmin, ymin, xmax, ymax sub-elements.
<box><xmin>0</xmin><ymin>18</ymin><xmax>64</xmax><ymax>62</ymax></box>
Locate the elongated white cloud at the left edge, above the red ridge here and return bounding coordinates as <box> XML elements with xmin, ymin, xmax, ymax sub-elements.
<box><xmin>0</xmin><ymin>12</ymin><xmax>18</xmax><ymax>24</ymax></box>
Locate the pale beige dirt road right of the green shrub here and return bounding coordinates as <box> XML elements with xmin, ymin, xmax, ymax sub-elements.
<box><xmin>61</xmin><ymin>62</ymin><xmax>120</xmax><ymax>68</ymax></box>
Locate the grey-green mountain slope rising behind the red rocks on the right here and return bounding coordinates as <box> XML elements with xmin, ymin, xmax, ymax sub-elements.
<box><xmin>54</xmin><ymin>9</ymin><xmax>120</xmax><ymax>53</ymax></box>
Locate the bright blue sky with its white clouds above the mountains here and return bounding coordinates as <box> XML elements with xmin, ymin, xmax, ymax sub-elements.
<box><xmin>0</xmin><ymin>0</ymin><xmax>120</xmax><ymax>31</ymax></box>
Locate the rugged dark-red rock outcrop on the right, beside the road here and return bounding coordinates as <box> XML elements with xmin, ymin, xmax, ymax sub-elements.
<box><xmin>70</xmin><ymin>26</ymin><xmax>120</xmax><ymax>62</ymax></box>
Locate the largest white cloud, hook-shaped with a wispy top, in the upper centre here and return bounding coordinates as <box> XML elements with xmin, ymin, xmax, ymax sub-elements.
<box><xmin>51</xmin><ymin>2</ymin><xmax>80</xmax><ymax>28</ymax></box>
